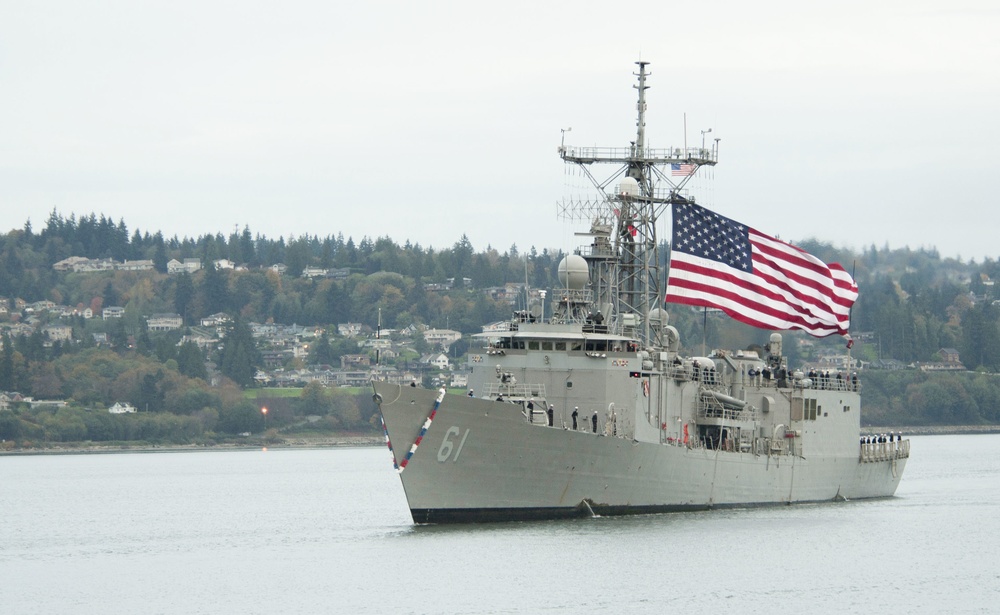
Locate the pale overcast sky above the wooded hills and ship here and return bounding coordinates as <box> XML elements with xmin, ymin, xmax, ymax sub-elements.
<box><xmin>0</xmin><ymin>0</ymin><xmax>1000</xmax><ymax>261</ymax></box>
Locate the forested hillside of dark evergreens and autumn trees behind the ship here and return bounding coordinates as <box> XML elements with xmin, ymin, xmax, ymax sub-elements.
<box><xmin>0</xmin><ymin>212</ymin><xmax>1000</xmax><ymax>448</ymax></box>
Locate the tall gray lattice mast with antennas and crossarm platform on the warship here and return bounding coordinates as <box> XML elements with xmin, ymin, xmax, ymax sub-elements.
<box><xmin>559</xmin><ymin>61</ymin><xmax>718</xmax><ymax>347</ymax></box>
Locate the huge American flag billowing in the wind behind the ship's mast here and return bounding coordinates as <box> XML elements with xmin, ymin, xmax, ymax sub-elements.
<box><xmin>666</xmin><ymin>203</ymin><xmax>858</xmax><ymax>337</ymax></box>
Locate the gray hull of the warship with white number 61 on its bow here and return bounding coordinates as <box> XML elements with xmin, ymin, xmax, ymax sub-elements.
<box><xmin>374</xmin><ymin>382</ymin><xmax>908</xmax><ymax>523</ymax></box>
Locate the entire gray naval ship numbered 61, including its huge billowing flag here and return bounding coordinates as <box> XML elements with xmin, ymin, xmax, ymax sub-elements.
<box><xmin>372</xmin><ymin>62</ymin><xmax>910</xmax><ymax>523</ymax></box>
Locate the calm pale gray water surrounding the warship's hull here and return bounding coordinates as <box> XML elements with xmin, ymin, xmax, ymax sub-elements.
<box><xmin>0</xmin><ymin>435</ymin><xmax>1000</xmax><ymax>615</ymax></box>
